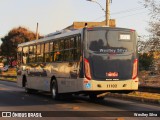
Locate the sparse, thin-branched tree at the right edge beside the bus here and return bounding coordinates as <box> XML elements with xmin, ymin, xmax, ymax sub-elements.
<box><xmin>138</xmin><ymin>0</ymin><xmax>160</xmax><ymax>70</ymax></box>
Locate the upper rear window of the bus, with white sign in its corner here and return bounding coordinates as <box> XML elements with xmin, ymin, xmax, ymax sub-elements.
<box><xmin>87</xmin><ymin>30</ymin><xmax>133</xmax><ymax>54</ymax></box>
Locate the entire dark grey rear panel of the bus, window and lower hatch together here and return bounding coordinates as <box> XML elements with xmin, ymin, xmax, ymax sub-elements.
<box><xmin>85</xmin><ymin>28</ymin><xmax>136</xmax><ymax>80</ymax></box>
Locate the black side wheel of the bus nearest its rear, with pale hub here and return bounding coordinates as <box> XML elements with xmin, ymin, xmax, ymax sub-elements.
<box><xmin>51</xmin><ymin>80</ymin><xmax>61</xmax><ymax>100</ymax></box>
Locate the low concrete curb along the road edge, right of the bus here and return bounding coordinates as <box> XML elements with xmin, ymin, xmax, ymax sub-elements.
<box><xmin>107</xmin><ymin>93</ymin><xmax>160</xmax><ymax>105</ymax></box>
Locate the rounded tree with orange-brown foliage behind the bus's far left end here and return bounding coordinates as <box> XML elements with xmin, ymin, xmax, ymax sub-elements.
<box><xmin>1</xmin><ymin>27</ymin><xmax>39</xmax><ymax>64</ymax></box>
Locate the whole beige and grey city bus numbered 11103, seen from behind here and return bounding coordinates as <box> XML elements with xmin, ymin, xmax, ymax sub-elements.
<box><xmin>17</xmin><ymin>27</ymin><xmax>138</xmax><ymax>99</ymax></box>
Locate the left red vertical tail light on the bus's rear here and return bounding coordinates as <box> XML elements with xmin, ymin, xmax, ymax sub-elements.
<box><xmin>84</xmin><ymin>58</ymin><xmax>91</xmax><ymax>80</ymax></box>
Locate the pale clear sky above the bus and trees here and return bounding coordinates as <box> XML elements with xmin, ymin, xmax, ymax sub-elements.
<box><xmin>0</xmin><ymin>0</ymin><xmax>150</xmax><ymax>43</ymax></box>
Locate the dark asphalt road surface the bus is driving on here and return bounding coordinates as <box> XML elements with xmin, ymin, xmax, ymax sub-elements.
<box><xmin>0</xmin><ymin>81</ymin><xmax>160</xmax><ymax>120</ymax></box>
